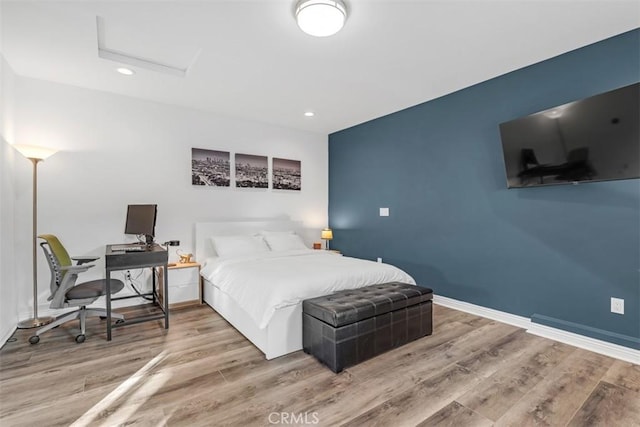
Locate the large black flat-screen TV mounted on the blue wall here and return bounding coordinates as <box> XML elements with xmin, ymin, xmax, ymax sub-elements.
<box><xmin>500</xmin><ymin>83</ymin><xmax>640</xmax><ymax>188</ymax></box>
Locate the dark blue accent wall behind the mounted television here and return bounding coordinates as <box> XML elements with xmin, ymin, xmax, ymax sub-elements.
<box><xmin>329</xmin><ymin>30</ymin><xmax>640</xmax><ymax>349</ymax></box>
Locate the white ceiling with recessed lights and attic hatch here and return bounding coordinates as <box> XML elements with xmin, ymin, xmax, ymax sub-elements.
<box><xmin>0</xmin><ymin>0</ymin><xmax>640</xmax><ymax>134</ymax></box>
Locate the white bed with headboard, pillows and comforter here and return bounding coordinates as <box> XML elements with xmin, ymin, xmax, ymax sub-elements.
<box><xmin>195</xmin><ymin>219</ymin><xmax>415</xmax><ymax>359</ymax></box>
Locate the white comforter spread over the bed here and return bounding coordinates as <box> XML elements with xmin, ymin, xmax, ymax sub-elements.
<box><xmin>202</xmin><ymin>250</ymin><xmax>415</xmax><ymax>329</ymax></box>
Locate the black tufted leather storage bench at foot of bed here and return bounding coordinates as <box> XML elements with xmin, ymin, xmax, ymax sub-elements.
<box><xmin>302</xmin><ymin>282</ymin><xmax>433</xmax><ymax>373</ymax></box>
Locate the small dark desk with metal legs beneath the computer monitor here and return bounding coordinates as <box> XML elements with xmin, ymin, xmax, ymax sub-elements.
<box><xmin>104</xmin><ymin>244</ymin><xmax>169</xmax><ymax>341</ymax></box>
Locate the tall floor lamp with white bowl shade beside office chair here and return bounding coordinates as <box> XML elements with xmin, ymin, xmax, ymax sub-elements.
<box><xmin>13</xmin><ymin>145</ymin><xmax>56</xmax><ymax>329</ymax></box>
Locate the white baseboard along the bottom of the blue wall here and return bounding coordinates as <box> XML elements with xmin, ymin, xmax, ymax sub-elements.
<box><xmin>433</xmin><ymin>295</ymin><xmax>640</xmax><ymax>364</ymax></box>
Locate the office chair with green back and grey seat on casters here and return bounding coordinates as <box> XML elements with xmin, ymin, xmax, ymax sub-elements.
<box><xmin>29</xmin><ymin>234</ymin><xmax>124</xmax><ymax>344</ymax></box>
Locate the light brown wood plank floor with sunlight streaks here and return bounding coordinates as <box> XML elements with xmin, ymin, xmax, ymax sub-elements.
<box><xmin>0</xmin><ymin>306</ymin><xmax>640</xmax><ymax>427</ymax></box>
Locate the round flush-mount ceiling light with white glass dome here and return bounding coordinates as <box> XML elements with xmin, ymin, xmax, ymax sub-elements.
<box><xmin>296</xmin><ymin>0</ymin><xmax>347</xmax><ymax>37</ymax></box>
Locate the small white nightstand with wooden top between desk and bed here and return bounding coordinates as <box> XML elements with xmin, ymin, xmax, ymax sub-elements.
<box><xmin>162</xmin><ymin>262</ymin><xmax>202</xmax><ymax>308</ymax></box>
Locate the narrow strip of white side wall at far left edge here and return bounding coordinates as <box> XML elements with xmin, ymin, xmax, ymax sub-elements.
<box><xmin>0</xmin><ymin>55</ymin><xmax>18</xmax><ymax>345</ymax></box>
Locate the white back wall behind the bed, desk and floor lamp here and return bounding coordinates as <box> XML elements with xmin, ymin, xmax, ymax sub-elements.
<box><xmin>15</xmin><ymin>77</ymin><xmax>328</xmax><ymax>320</ymax></box>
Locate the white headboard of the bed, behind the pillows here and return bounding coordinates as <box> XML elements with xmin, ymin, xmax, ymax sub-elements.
<box><xmin>195</xmin><ymin>218</ymin><xmax>320</xmax><ymax>263</ymax></box>
